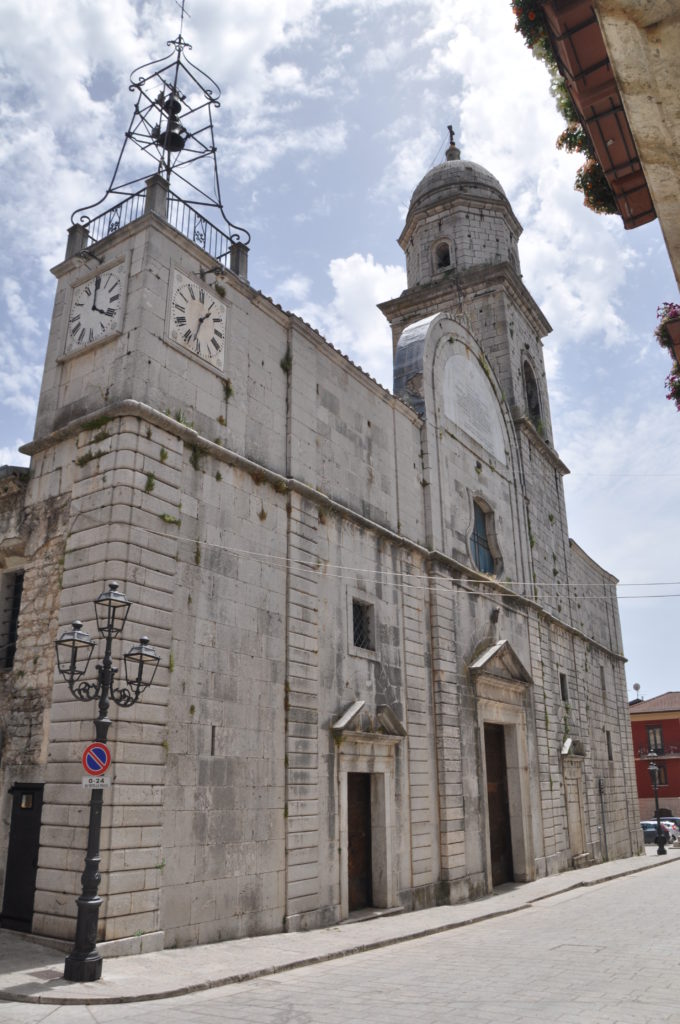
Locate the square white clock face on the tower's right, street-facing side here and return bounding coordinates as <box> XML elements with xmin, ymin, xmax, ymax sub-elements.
<box><xmin>170</xmin><ymin>271</ymin><xmax>226</xmax><ymax>370</ymax></box>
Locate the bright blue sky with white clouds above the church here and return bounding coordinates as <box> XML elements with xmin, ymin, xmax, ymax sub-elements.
<box><xmin>0</xmin><ymin>0</ymin><xmax>680</xmax><ymax>697</ymax></box>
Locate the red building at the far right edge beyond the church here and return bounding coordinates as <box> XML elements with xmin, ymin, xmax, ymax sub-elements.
<box><xmin>629</xmin><ymin>691</ymin><xmax>680</xmax><ymax>820</ymax></box>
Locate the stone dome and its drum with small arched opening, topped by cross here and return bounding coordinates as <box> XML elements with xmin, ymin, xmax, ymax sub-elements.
<box><xmin>398</xmin><ymin>125</ymin><xmax>521</xmax><ymax>288</ymax></box>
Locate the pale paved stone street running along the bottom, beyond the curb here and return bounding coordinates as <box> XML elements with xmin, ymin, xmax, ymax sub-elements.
<box><xmin>0</xmin><ymin>858</ymin><xmax>680</xmax><ymax>1024</ymax></box>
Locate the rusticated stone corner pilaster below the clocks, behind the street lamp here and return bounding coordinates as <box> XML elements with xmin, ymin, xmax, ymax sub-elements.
<box><xmin>33</xmin><ymin>417</ymin><xmax>181</xmax><ymax>948</ymax></box>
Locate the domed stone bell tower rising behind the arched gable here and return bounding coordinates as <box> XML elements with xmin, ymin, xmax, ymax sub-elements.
<box><xmin>380</xmin><ymin>126</ymin><xmax>552</xmax><ymax>444</ymax></box>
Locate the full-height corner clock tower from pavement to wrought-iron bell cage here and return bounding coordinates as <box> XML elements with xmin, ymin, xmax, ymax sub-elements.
<box><xmin>19</xmin><ymin>28</ymin><xmax>258</xmax><ymax>950</ymax></box>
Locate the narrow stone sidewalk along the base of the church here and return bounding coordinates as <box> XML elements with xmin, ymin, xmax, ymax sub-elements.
<box><xmin>0</xmin><ymin>847</ymin><xmax>680</xmax><ymax>1006</ymax></box>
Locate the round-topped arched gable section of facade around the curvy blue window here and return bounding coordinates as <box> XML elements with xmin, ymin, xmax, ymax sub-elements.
<box><xmin>394</xmin><ymin>313</ymin><xmax>528</xmax><ymax>579</ymax></box>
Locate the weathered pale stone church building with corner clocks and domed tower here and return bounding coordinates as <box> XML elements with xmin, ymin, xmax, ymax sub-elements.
<box><xmin>0</xmin><ymin>134</ymin><xmax>641</xmax><ymax>952</ymax></box>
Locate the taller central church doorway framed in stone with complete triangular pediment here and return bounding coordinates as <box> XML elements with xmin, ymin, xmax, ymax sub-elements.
<box><xmin>470</xmin><ymin>640</ymin><xmax>536</xmax><ymax>892</ymax></box>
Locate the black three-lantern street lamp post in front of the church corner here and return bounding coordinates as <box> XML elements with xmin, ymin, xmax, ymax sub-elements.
<box><xmin>55</xmin><ymin>583</ymin><xmax>160</xmax><ymax>981</ymax></box>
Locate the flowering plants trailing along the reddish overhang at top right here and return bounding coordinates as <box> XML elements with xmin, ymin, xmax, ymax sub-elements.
<box><xmin>512</xmin><ymin>0</ymin><xmax>619</xmax><ymax>213</ymax></box>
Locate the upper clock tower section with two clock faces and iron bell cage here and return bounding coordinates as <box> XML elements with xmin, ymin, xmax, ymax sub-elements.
<box><xmin>35</xmin><ymin>24</ymin><xmax>250</xmax><ymax>443</ymax></box>
